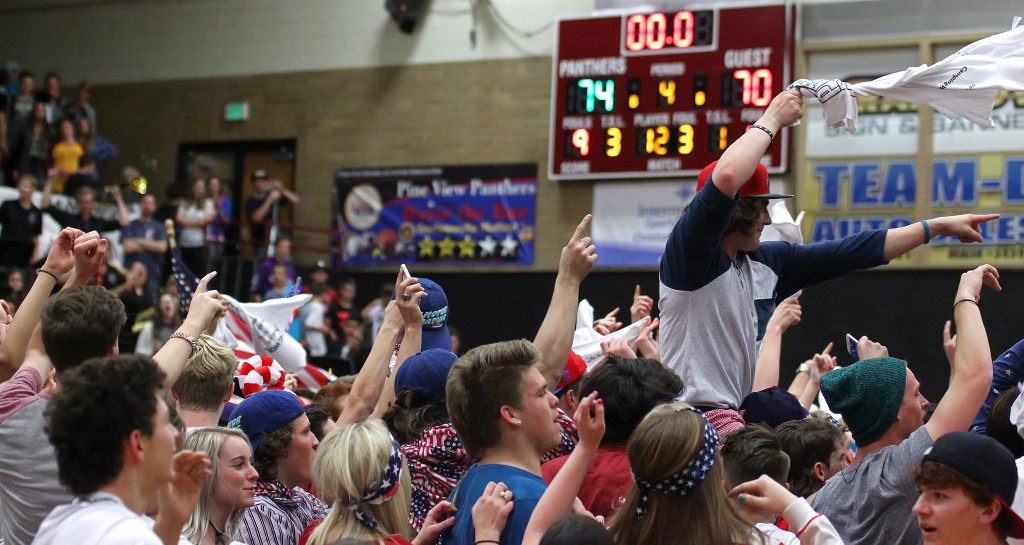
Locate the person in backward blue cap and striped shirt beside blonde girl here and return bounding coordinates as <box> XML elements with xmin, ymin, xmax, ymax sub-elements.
<box><xmin>228</xmin><ymin>390</ymin><xmax>328</xmax><ymax>545</ymax></box>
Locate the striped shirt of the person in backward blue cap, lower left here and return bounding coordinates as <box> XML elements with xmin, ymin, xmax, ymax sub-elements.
<box><xmin>238</xmin><ymin>480</ymin><xmax>330</xmax><ymax>545</ymax></box>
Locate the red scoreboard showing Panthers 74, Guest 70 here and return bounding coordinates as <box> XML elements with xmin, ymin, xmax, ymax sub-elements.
<box><xmin>548</xmin><ymin>5</ymin><xmax>794</xmax><ymax>179</ymax></box>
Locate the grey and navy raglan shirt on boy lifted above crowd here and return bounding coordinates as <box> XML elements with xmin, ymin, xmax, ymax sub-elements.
<box><xmin>658</xmin><ymin>179</ymin><xmax>886</xmax><ymax>409</ymax></box>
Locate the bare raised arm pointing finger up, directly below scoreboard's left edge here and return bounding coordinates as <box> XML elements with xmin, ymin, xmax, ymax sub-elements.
<box><xmin>534</xmin><ymin>214</ymin><xmax>597</xmax><ymax>391</ymax></box>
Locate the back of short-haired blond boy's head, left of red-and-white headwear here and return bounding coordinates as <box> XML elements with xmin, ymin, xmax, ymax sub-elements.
<box><xmin>171</xmin><ymin>335</ymin><xmax>236</xmax><ymax>432</ymax></box>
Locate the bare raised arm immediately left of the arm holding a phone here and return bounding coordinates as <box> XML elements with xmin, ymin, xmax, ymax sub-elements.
<box><xmin>338</xmin><ymin>301</ymin><xmax>406</xmax><ymax>426</ymax></box>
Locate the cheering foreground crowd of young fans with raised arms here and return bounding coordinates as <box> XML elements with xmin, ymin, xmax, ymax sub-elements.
<box><xmin>0</xmin><ymin>91</ymin><xmax>1024</xmax><ymax>545</ymax></box>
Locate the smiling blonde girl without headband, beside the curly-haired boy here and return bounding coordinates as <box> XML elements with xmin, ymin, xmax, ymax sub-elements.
<box><xmin>179</xmin><ymin>427</ymin><xmax>259</xmax><ymax>545</ymax></box>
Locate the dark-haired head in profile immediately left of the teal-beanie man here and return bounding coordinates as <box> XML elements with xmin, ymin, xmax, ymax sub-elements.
<box><xmin>775</xmin><ymin>418</ymin><xmax>847</xmax><ymax>501</ymax></box>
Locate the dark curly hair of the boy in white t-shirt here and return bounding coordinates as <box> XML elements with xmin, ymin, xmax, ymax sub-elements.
<box><xmin>46</xmin><ymin>355</ymin><xmax>167</xmax><ymax>496</ymax></box>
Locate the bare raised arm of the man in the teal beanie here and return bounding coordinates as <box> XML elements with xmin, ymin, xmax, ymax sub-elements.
<box><xmin>925</xmin><ymin>264</ymin><xmax>1002</xmax><ymax>439</ymax></box>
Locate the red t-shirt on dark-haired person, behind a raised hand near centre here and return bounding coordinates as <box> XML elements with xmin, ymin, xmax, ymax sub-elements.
<box><xmin>541</xmin><ymin>447</ymin><xmax>633</xmax><ymax>520</ymax></box>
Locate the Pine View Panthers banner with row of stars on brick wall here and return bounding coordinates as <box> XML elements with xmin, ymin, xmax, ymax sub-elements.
<box><xmin>334</xmin><ymin>164</ymin><xmax>538</xmax><ymax>265</ymax></box>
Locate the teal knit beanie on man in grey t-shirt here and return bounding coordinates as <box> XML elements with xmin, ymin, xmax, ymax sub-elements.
<box><xmin>821</xmin><ymin>358</ymin><xmax>906</xmax><ymax>446</ymax></box>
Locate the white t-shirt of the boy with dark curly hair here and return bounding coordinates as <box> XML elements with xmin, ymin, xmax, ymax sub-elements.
<box><xmin>32</xmin><ymin>492</ymin><xmax>163</xmax><ymax>545</ymax></box>
